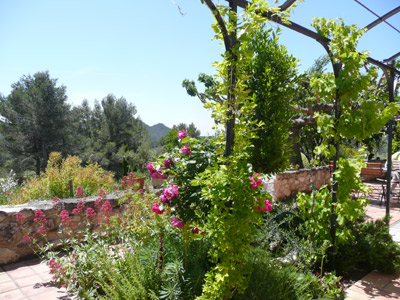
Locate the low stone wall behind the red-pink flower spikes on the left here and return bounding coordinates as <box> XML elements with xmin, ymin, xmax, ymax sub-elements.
<box><xmin>0</xmin><ymin>194</ymin><xmax>119</xmax><ymax>265</ymax></box>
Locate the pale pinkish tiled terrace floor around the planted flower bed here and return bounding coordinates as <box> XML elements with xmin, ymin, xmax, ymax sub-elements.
<box><xmin>0</xmin><ymin>186</ymin><xmax>400</xmax><ymax>300</ymax></box>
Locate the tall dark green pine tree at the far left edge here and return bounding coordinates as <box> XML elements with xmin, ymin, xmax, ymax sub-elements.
<box><xmin>0</xmin><ymin>71</ymin><xmax>70</xmax><ymax>175</ymax></box>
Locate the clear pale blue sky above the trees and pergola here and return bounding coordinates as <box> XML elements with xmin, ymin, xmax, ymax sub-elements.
<box><xmin>0</xmin><ymin>0</ymin><xmax>400</xmax><ymax>134</ymax></box>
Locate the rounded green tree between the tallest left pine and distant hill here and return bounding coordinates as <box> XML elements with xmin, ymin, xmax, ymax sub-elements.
<box><xmin>69</xmin><ymin>94</ymin><xmax>150</xmax><ymax>177</ymax></box>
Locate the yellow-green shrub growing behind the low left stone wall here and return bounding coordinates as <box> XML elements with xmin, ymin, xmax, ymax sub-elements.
<box><xmin>10</xmin><ymin>152</ymin><xmax>114</xmax><ymax>203</ymax></box>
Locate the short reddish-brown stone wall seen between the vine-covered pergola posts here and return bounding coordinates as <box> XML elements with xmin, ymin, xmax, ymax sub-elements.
<box><xmin>273</xmin><ymin>166</ymin><xmax>331</xmax><ymax>199</ymax></box>
